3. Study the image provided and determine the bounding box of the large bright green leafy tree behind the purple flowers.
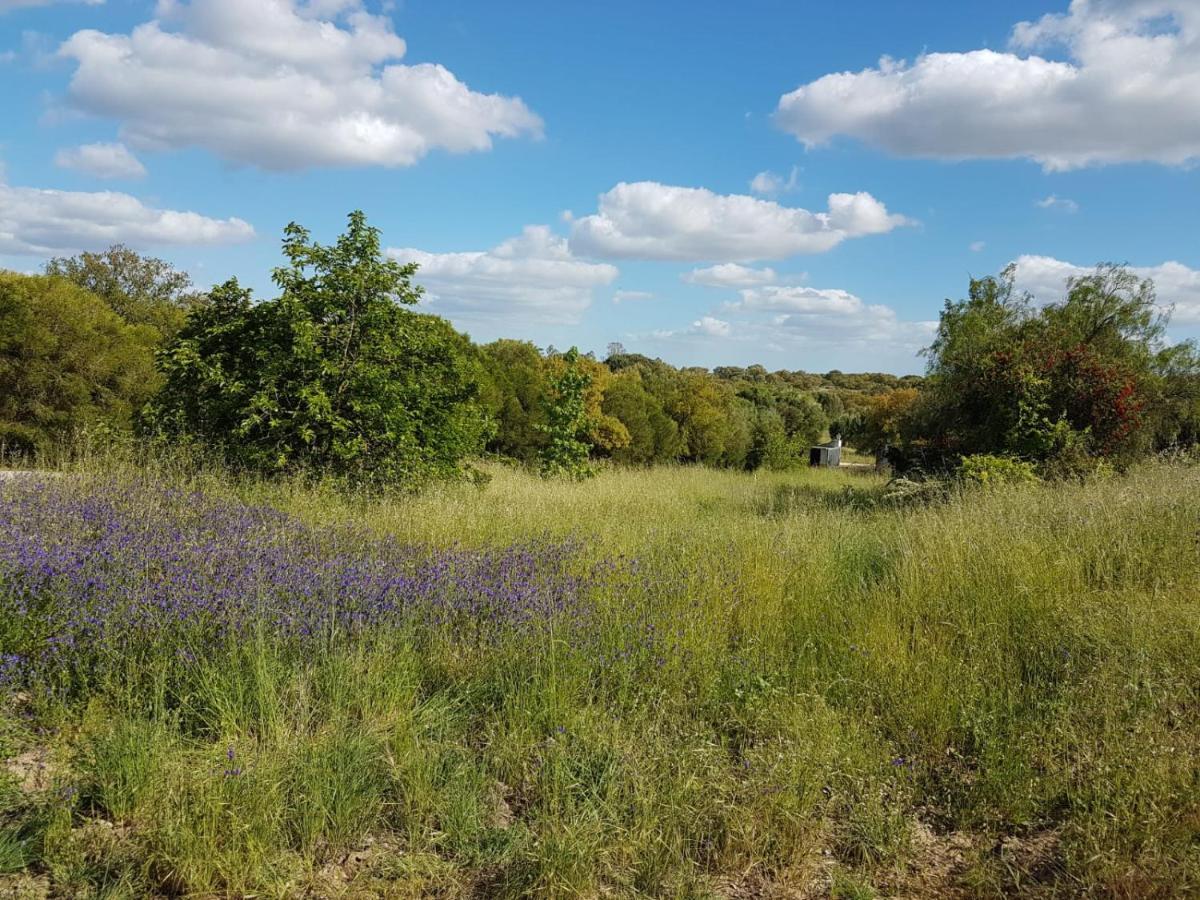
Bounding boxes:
[149,212,488,482]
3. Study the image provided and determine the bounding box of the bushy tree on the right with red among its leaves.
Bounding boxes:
[905,265,1194,470]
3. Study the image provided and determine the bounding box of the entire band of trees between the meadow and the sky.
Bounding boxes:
[0,214,1200,484]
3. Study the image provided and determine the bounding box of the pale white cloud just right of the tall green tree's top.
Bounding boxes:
[388,226,619,323]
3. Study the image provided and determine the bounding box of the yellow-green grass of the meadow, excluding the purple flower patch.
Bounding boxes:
[7,464,1200,898]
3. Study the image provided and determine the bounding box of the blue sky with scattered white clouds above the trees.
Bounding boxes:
[0,0,1200,373]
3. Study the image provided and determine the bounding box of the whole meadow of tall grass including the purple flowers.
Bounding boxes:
[0,463,1200,898]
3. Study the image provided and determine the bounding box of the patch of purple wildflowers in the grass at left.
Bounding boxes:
[0,479,599,682]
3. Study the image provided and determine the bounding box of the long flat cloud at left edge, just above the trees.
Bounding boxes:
[0,174,254,256]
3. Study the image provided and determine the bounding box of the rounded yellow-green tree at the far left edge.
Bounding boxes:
[0,272,158,452]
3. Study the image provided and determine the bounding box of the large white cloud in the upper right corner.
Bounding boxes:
[775,0,1200,170]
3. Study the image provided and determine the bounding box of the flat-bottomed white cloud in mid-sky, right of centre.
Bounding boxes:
[571,181,907,262]
